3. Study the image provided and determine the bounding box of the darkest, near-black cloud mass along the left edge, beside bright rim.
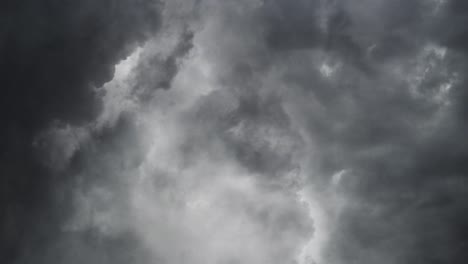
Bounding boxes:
[0,0,160,263]
